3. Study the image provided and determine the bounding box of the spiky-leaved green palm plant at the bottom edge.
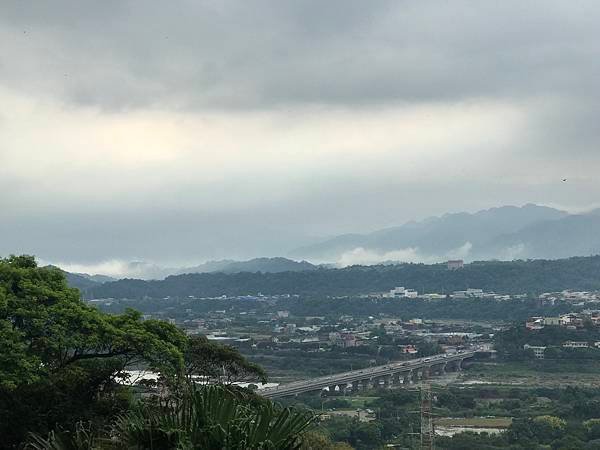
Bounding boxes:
[113,385,315,450]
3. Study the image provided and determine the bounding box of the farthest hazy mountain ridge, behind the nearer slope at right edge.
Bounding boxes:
[291,204,568,261]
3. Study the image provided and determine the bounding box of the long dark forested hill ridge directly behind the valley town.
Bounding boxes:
[83,256,600,298]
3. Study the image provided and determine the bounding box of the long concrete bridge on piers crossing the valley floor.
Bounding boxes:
[257,350,475,398]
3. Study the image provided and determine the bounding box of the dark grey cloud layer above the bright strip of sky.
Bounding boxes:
[0,1,600,109]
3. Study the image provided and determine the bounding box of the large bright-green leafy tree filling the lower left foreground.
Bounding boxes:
[0,256,187,448]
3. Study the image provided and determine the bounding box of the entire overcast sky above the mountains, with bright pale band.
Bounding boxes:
[0,0,600,270]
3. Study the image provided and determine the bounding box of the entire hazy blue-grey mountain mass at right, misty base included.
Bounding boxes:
[290,204,600,264]
